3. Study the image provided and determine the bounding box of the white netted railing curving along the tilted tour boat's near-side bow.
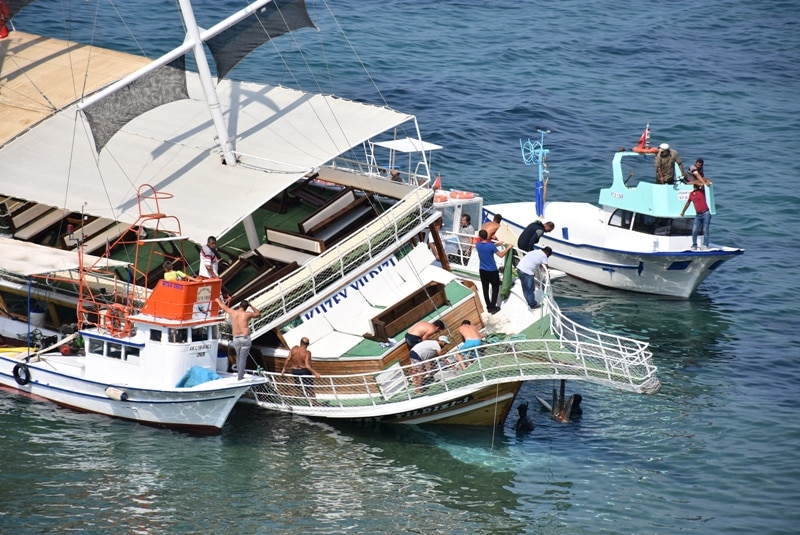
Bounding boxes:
[252,339,660,417]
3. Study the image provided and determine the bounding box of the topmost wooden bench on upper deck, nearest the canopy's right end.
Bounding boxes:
[297,188,376,245]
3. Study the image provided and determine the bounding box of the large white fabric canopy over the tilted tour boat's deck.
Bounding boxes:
[0,33,413,243]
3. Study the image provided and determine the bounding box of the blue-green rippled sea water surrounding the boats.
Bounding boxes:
[0,0,800,534]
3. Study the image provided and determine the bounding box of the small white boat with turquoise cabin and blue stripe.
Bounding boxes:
[484,127,744,298]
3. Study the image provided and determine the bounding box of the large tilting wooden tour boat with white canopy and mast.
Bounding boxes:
[0,0,659,425]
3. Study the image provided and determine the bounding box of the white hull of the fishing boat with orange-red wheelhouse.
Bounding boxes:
[0,356,260,433]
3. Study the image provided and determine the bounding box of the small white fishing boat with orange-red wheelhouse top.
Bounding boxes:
[0,186,265,433]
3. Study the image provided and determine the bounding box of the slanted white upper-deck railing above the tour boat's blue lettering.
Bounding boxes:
[245,188,434,336]
